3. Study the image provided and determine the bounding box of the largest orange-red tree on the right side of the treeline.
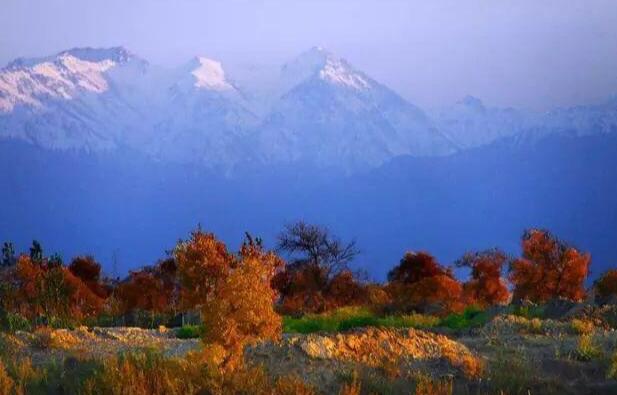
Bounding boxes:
[509,229,591,302]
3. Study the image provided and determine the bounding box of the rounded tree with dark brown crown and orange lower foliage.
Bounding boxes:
[386,252,463,314]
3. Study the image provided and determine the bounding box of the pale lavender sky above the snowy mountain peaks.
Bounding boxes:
[0,0,617,111]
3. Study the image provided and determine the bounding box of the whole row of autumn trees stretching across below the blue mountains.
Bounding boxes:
[0,222,617,334]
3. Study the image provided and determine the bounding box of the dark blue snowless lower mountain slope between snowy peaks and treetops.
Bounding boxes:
[0,134,617,278]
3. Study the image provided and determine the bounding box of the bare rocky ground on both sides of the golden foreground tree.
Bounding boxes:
[3,315,617,394]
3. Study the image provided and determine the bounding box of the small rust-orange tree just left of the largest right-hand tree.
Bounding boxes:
[456,249,510,307]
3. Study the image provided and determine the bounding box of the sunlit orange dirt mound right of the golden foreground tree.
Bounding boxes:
[246,328,482,393]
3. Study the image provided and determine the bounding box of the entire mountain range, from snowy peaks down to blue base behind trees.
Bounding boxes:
[0,47,617,277]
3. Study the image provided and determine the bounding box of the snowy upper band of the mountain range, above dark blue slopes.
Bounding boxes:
[0,47,617,172]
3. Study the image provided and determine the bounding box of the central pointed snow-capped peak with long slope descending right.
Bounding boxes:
[254,47,455,170]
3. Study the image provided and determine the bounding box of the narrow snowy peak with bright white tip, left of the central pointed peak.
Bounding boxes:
[147,57,257,168]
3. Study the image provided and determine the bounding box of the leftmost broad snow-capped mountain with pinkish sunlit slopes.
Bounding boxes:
[0,48,148,151]
